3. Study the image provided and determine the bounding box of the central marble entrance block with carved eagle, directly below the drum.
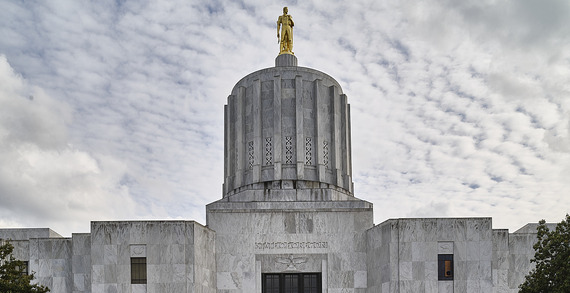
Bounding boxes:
[207,197,372,293]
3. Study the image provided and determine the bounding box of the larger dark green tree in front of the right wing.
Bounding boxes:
[519,215,570,293]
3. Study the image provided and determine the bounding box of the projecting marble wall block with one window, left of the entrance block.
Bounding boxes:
[91,221,215,293]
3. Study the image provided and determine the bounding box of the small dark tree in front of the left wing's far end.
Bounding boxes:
[0,242,50,293]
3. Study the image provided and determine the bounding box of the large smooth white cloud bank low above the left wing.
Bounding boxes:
[0,55,135,235]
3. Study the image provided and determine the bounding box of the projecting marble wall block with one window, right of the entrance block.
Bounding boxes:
[368,218,493,293]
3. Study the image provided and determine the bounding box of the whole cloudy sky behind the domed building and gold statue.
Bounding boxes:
[0,0,570,236]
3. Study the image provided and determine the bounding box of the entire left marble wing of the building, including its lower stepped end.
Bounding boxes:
[0,221,216,293]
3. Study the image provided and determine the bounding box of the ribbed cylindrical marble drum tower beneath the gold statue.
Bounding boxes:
[223,55,353,197]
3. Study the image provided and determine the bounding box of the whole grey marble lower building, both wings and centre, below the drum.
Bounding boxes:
[0,214,536,293]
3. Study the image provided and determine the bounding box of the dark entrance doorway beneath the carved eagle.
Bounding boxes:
[261,273,321,293]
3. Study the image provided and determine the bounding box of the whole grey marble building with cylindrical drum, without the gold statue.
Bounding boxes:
[0,54,536,293]
